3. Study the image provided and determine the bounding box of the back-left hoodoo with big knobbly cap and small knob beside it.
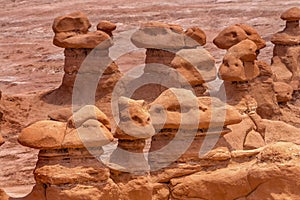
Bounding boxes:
[46,12,121,104]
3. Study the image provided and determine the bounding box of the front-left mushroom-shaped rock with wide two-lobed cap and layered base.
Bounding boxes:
[18,105,118,200]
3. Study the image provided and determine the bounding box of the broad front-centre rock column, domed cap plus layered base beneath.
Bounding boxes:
[149,88,242,183]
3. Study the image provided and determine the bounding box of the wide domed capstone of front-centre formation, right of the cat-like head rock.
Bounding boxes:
[150,88,242,129]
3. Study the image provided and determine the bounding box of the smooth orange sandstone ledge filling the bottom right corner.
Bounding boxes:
[170,143,300,200]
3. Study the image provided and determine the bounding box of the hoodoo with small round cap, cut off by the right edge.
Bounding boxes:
[271,7,300,90]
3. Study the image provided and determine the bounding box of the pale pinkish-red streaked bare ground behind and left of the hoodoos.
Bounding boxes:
[0,0,300,196]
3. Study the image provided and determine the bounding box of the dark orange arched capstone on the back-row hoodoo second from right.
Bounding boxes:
[213,24,266,50]
